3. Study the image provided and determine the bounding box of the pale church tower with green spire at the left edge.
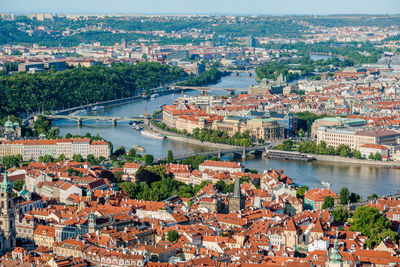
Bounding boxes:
[0,172,16,253]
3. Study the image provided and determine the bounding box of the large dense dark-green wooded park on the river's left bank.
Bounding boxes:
[0,62,186,116]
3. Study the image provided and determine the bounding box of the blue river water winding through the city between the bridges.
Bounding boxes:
[54,73,400,197]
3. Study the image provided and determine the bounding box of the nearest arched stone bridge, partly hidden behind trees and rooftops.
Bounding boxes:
[156,146,268,161]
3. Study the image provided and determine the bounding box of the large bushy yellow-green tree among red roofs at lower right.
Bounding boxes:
[351,206,399,249]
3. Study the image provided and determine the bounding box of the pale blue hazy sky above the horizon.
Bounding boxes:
[0,0,400,15]
